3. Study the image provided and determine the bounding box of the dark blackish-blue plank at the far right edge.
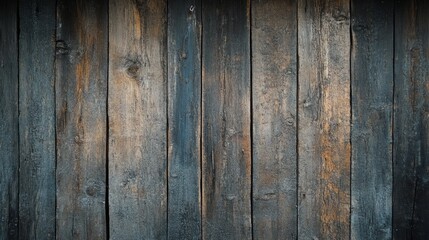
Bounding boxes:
[393,0,429,239]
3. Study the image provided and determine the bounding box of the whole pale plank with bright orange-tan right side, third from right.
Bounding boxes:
[298,0,351,239]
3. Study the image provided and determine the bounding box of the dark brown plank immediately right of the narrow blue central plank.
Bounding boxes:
[202,0,252,239]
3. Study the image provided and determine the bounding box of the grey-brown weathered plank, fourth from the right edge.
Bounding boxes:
[252,0,297,239]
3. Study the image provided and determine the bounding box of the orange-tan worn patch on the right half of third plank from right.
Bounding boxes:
[320,77,351,238]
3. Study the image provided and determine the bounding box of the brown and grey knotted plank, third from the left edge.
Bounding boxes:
[56,0,108,239]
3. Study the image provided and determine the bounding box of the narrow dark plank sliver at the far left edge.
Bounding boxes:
[0,0,19,239]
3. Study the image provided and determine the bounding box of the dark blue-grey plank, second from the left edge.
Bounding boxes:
[19,0,56,239]
